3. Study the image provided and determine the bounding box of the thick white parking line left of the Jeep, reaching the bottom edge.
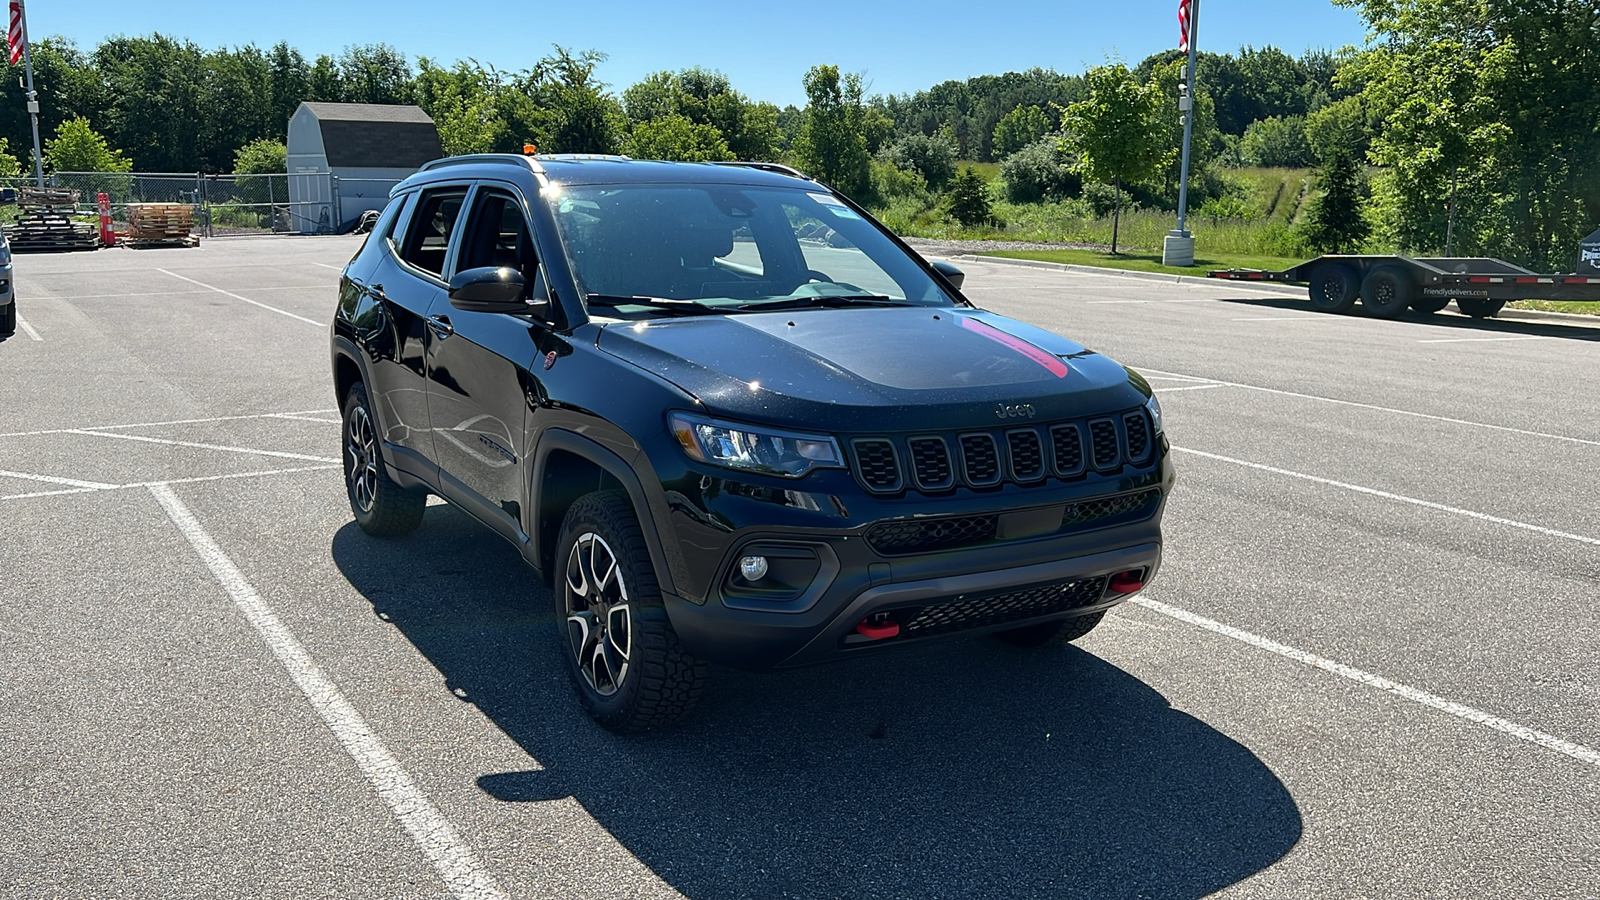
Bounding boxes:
[150,484,506,900]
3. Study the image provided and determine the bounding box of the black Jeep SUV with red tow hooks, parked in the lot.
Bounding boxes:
[333,155,1173,730]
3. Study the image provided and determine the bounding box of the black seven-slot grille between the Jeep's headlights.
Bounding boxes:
[851,410,1155,493]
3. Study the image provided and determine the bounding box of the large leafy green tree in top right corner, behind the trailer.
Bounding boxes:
[1339,0,1600,269]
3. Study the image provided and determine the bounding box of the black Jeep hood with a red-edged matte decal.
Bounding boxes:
[598,307,1150,432]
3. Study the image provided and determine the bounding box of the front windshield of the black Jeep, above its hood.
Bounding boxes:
[546,184,952,312]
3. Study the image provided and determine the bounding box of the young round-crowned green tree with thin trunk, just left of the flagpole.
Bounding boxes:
[1062,62,1174,253]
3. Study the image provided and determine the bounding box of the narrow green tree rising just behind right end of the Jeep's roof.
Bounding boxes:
[795,66,872,197]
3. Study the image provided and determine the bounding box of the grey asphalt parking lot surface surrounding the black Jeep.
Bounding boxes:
[0,239,1600,898]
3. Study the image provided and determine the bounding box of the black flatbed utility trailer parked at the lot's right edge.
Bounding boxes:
[1206,255,1600,319]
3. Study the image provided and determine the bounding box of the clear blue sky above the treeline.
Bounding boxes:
[37,0,1363,106]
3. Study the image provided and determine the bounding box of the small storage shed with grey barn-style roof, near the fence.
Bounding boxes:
[288,102,445,234]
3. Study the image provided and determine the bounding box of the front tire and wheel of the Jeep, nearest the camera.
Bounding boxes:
[550,490,706,733]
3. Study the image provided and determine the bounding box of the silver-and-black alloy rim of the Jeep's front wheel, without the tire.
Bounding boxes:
[565,532,634,697]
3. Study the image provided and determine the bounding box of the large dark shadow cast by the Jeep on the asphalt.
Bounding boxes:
[333,506,1302,898]
